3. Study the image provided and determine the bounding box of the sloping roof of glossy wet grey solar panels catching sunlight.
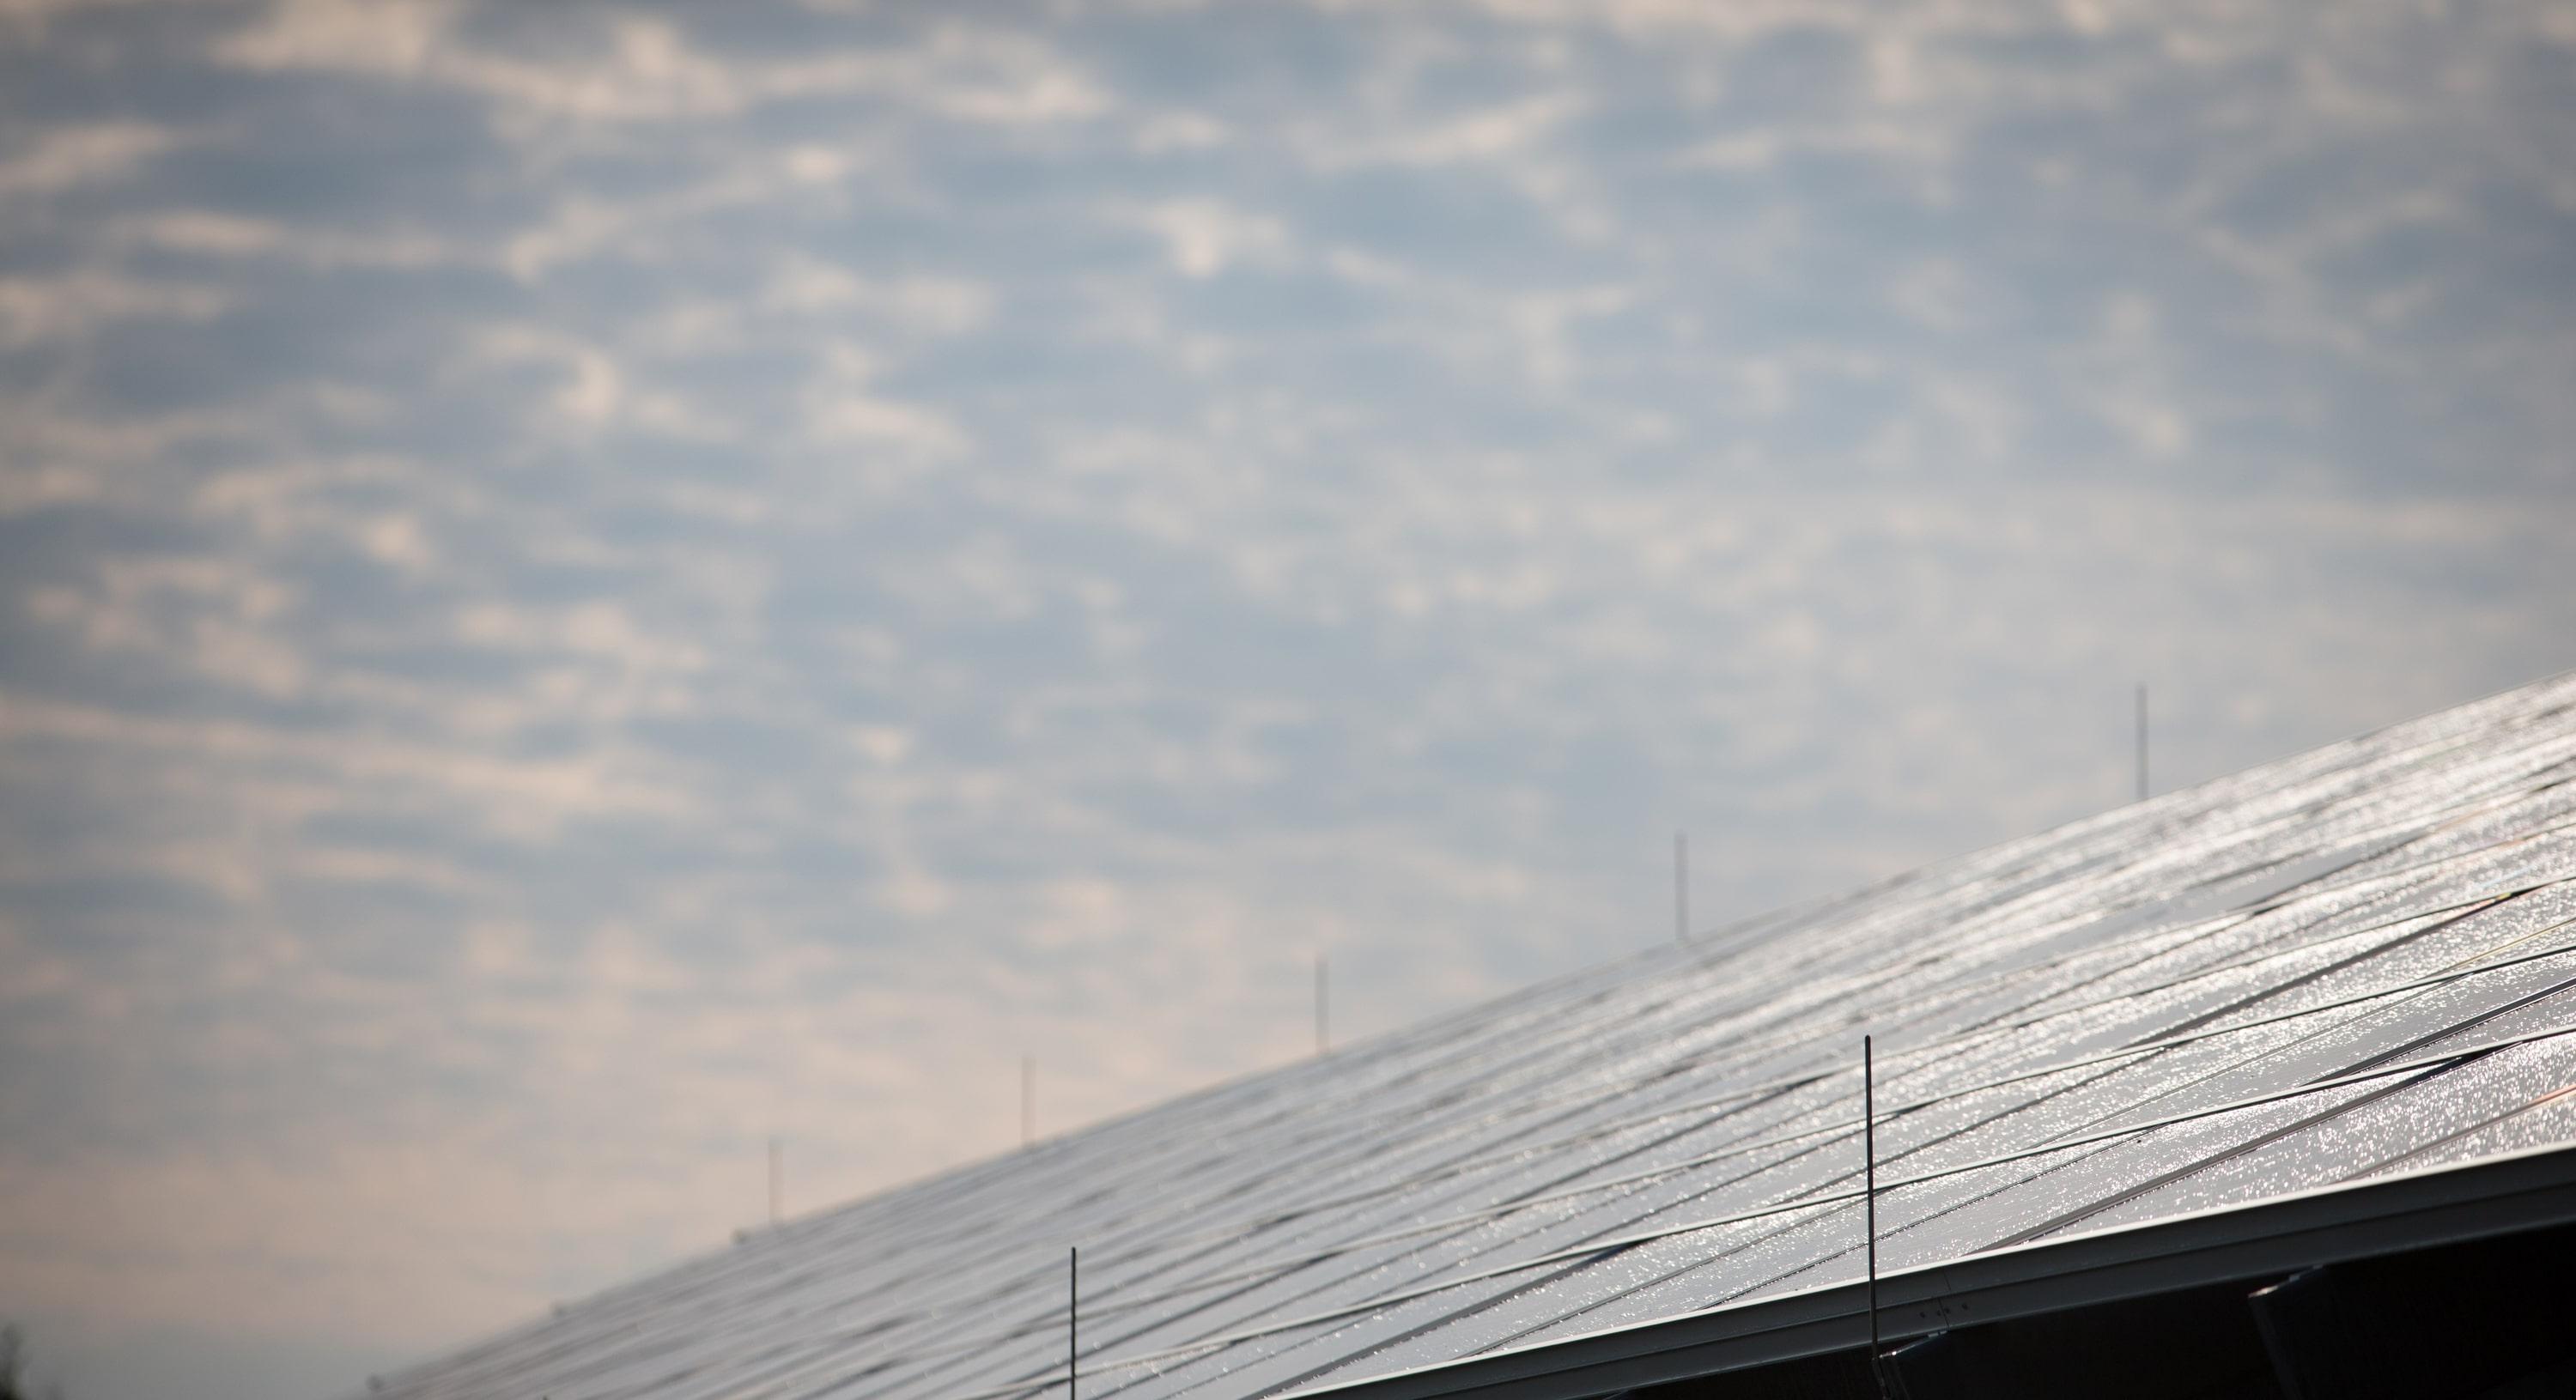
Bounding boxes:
[368,677,2576,1400]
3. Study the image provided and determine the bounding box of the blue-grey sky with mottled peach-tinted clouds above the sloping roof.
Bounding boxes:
[0,0,2576,1400]
